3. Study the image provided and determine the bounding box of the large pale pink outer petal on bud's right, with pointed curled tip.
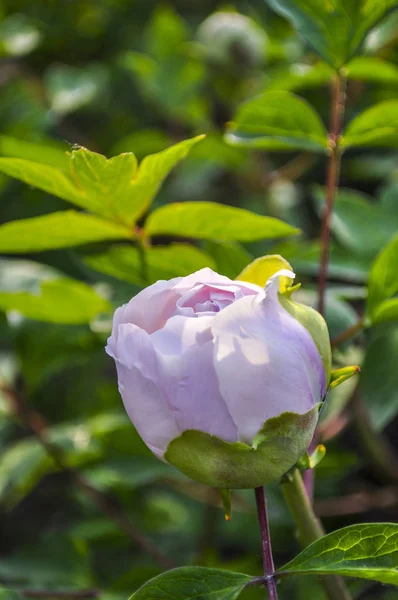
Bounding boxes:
[212,271,325,443]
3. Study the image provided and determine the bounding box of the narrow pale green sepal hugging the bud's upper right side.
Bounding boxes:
[279,294,332,385]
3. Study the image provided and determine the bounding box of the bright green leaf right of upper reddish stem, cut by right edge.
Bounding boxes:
[340,100,398,148]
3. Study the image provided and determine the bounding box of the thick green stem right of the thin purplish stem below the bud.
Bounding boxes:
[282,469,351,600]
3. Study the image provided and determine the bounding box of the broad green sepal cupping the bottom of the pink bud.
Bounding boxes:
[164,404,320,489]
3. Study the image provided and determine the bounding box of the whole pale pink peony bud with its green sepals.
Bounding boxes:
[106,269,330,488]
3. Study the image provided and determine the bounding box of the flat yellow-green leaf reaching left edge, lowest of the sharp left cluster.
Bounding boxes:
[0,210,133,254]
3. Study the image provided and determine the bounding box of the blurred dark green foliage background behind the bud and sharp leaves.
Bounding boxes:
[0,0,398,600]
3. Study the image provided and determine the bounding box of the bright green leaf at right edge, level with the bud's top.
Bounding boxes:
[366,235,398,321]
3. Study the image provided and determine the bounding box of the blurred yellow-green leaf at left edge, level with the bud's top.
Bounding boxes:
[0,279,111,323]
